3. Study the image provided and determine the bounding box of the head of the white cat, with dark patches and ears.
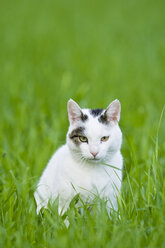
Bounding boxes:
[67,99,122,163]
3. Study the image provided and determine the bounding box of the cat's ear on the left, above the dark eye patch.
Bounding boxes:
[68,99,82,124]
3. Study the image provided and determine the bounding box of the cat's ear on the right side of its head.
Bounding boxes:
[103,99,121,123]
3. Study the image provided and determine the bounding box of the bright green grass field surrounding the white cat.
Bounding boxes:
[0,0,165,248]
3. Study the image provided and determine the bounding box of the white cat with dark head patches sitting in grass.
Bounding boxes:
[34,99,123,213]
